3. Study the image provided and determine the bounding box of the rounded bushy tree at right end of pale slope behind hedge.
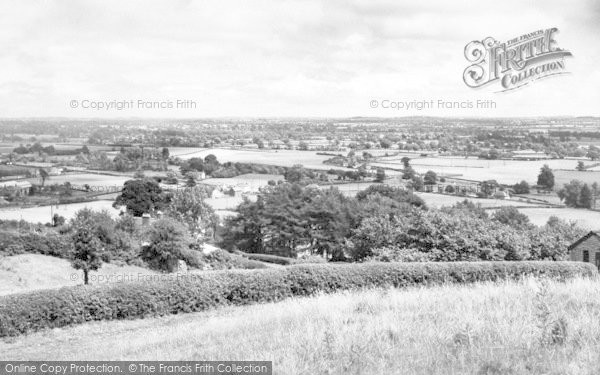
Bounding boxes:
[142,218,191,272]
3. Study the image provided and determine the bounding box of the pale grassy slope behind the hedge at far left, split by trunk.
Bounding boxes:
[0,254,156,295]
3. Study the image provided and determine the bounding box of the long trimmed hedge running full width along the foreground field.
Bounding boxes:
[0,262,597,337]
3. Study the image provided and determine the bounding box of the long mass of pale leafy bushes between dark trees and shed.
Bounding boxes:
[348,205,583,262]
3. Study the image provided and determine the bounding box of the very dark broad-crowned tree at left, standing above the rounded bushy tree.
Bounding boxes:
[113,179,167,216]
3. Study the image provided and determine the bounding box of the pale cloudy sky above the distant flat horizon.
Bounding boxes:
[0,0,600,118]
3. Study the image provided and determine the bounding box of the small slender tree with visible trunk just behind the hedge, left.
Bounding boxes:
[71,226,102,284]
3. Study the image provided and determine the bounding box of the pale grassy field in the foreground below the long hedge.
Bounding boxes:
[0,279,600,374]
